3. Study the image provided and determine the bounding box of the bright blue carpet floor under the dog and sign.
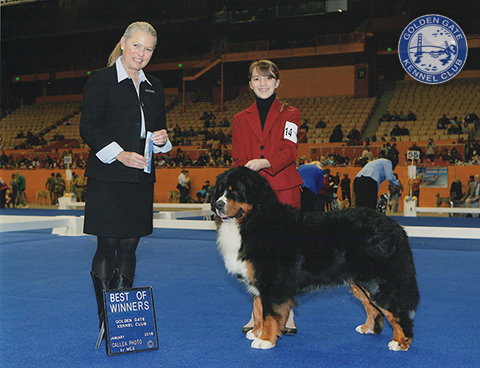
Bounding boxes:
[0,224,480,368]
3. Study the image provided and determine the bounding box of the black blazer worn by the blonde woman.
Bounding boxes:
[80,65,166,183]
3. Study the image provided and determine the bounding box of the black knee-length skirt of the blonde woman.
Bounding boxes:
[84,172,154,238]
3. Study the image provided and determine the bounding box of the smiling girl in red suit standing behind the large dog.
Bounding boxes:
[232,60,303,334]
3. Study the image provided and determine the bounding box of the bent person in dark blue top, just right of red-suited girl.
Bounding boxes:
[298,161,324,212]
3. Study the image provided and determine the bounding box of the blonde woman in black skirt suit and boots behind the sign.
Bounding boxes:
[80,22,172,344]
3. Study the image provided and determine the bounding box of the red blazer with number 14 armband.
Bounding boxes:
[232,99,303,190]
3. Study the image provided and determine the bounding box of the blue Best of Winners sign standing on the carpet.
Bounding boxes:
[104,287,158,355]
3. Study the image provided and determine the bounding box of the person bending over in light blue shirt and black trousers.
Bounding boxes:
[353,156,400,209]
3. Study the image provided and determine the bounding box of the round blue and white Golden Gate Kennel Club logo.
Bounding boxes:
[398,15,468,84]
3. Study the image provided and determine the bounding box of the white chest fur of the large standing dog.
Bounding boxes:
[217,222,247,279]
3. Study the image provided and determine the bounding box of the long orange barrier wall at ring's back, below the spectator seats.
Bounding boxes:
[0,165,480,209]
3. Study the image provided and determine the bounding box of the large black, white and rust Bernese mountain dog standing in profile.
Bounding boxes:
[211,167,419,351]
